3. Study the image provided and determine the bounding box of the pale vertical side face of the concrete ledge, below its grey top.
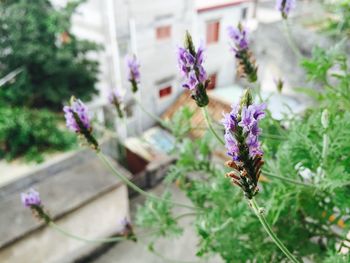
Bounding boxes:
[0,186,129,263]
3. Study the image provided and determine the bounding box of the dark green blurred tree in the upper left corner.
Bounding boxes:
[0,0,98,110]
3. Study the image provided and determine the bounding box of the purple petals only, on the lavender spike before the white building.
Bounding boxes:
[178,46,207,90]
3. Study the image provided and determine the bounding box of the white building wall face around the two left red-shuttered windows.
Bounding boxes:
[116,0,194,130]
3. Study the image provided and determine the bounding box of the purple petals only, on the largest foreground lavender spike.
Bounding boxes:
[222,104,266,161]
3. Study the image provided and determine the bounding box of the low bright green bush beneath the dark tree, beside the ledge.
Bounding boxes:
[0,108,75,162]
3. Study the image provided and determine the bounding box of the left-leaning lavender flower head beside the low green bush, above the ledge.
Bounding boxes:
[63,97,99,150]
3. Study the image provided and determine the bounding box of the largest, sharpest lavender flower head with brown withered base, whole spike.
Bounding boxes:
[222,90,266,199]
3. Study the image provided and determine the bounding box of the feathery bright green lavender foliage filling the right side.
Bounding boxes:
[135,39,350,262]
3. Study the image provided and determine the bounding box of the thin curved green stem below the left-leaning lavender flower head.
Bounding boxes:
[97,152,197,209]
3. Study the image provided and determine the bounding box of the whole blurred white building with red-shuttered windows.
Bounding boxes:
[53,0,253,135]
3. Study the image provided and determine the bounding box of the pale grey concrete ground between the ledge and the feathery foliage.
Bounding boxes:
[91,184,223,263]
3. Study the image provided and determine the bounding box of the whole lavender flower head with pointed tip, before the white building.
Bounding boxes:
[177,32,209,107]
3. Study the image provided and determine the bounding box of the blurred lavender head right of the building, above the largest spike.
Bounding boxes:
[227,24,258,82]
